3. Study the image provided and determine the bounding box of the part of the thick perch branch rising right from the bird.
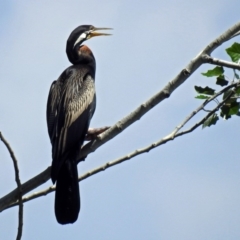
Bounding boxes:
[79,22,240,159]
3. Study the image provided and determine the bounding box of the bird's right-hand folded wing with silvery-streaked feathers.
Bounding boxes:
[52,75,96,181]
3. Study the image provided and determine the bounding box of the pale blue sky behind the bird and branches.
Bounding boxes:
[0,0,240,240]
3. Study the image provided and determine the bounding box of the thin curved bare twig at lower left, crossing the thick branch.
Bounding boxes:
[0,132,23,240]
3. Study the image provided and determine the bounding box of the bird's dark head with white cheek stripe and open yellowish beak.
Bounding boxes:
[66,25,111,64]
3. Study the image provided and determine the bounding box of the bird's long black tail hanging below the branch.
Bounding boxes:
[55,160,80,224]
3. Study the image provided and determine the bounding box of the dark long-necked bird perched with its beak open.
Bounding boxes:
[47,25,111,224]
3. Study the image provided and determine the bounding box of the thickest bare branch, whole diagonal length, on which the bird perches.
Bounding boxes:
[0,22,240,214]
